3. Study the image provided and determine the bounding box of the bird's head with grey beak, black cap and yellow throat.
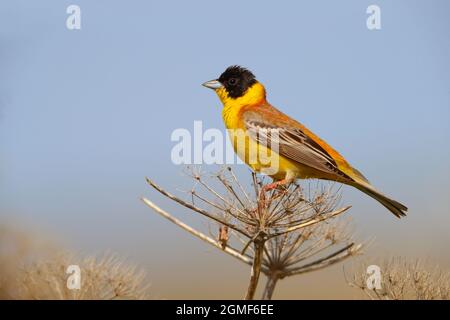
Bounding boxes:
[203,66,266,105]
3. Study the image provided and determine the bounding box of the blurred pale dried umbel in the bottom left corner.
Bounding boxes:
[19,254,147,300]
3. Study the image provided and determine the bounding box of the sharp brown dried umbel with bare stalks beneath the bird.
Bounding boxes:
[143,167,361,299]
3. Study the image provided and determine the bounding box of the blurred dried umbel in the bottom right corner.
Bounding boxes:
[347,258,450,300]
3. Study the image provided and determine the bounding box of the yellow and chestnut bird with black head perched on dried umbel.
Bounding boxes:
[203,65,408,218]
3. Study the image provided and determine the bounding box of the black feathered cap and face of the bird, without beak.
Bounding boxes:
[217,66,257,99]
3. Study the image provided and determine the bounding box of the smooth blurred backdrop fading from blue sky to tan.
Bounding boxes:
[0,0,450,299]
